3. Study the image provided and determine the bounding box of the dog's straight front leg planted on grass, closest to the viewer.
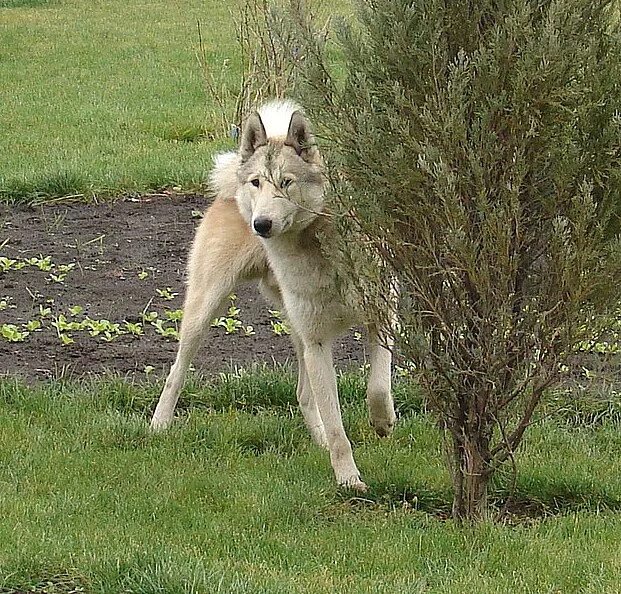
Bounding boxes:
[304,342,367,491]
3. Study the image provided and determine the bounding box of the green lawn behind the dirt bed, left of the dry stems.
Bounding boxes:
[0,0,237,200]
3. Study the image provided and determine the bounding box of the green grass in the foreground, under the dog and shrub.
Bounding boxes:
[0,370,621,594]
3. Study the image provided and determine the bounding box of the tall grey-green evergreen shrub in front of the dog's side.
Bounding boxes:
[292,0,621,516]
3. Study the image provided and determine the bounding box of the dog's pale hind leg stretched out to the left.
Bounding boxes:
[151,273,237,430]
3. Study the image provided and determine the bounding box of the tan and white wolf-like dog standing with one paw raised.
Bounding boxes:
[151,101,395,490]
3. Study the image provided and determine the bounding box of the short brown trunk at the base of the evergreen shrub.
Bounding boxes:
[451,427,492,523]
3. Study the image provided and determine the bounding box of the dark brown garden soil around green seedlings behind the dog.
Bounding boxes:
[0,193,364,380]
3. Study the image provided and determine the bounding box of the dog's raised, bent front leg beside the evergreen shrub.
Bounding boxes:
[367,326,397,437]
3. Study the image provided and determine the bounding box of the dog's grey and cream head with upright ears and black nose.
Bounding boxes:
[236,103,324,238]
